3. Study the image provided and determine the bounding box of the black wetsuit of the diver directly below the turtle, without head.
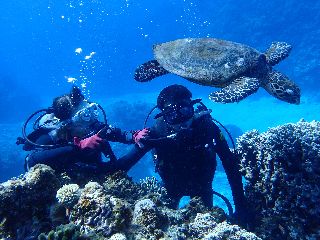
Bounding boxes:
[116,114,245,211]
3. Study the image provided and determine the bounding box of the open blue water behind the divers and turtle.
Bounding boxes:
[0,0,320,210]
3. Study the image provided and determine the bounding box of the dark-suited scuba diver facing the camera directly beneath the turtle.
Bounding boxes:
[114,85,248,226]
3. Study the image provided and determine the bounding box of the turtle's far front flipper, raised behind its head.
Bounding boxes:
[265,42,292,66]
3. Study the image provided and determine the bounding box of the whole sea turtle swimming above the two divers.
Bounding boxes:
[134,38,300,104]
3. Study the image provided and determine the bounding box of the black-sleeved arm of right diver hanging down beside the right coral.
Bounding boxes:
[214,125,246,213]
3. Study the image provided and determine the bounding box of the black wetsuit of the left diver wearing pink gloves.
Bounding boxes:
[24,123,134,174]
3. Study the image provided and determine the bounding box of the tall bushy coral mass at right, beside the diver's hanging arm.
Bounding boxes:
[237,120,320,239]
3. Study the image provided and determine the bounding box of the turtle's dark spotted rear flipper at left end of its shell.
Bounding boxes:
[134,60,169,82]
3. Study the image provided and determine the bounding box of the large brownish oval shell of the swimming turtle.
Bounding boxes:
[153,38,261,87]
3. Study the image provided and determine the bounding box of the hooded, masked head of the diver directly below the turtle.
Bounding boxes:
[156,84,194,125]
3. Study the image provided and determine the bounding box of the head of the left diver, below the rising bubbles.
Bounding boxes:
[52,95,73,121]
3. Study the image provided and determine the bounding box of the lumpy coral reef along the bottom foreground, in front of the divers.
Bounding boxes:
[0,165,259,240]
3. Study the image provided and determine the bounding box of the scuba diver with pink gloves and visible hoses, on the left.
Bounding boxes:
[17,86,137,174]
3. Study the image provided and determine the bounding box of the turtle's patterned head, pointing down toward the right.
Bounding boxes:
[262,70,300,104]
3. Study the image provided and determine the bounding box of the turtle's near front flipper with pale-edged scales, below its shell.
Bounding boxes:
[209,77,260,103]
